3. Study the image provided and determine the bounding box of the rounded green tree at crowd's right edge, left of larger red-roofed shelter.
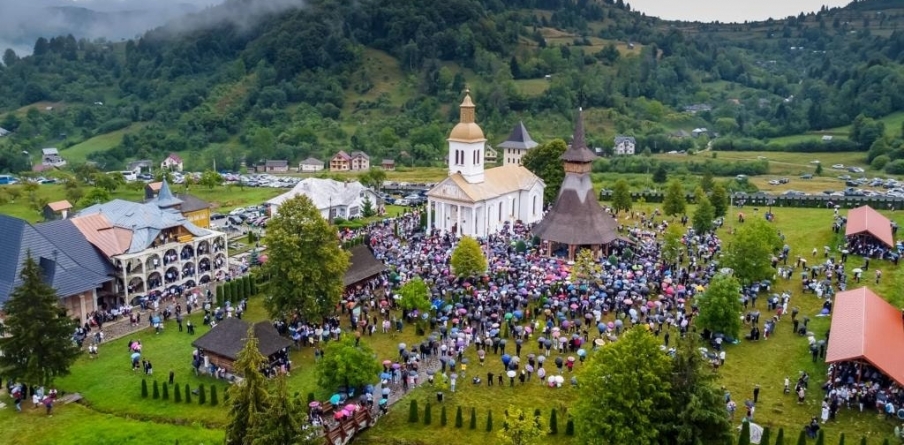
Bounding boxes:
[695,274,742,337]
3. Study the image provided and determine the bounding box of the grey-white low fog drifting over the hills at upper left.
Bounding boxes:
[0,0,304,56]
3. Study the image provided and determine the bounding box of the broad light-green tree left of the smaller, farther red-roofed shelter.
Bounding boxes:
[724,218,782,284]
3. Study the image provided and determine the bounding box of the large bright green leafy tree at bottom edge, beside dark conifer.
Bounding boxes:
[571,328,672,445]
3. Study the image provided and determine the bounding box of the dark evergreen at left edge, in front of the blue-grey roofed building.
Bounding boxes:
[0,253,80,387]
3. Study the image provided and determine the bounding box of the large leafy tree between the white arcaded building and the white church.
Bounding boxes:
[259,195,350,320]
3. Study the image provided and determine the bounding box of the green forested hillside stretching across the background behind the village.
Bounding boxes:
[0,0,904,171]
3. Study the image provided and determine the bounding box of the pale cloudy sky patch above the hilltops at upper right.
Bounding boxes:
[625,0,850,22]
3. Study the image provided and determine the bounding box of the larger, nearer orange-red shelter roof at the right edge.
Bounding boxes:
[826,287,904,385]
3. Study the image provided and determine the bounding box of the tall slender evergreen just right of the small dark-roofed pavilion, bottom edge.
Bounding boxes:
[226,328,272,445]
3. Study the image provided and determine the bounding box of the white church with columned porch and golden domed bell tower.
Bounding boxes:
[427,91,546,237]
